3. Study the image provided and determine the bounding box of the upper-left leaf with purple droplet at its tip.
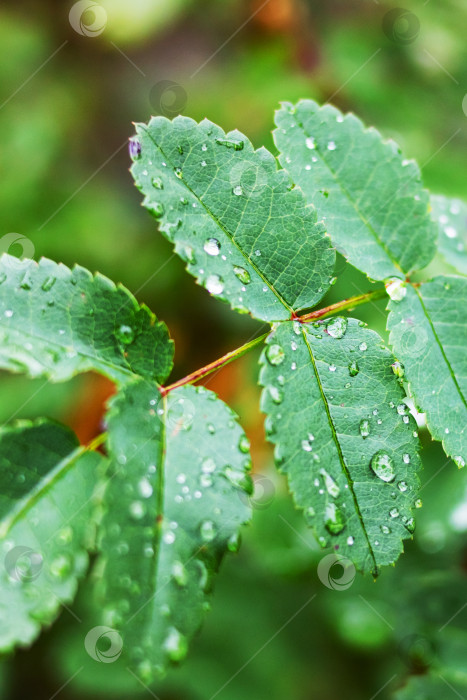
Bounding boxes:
[130,117,335,321]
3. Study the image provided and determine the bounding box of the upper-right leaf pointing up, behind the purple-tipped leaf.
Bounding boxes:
[274,100,436,280]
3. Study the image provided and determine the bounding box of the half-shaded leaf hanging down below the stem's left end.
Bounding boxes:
[94,380,252,682]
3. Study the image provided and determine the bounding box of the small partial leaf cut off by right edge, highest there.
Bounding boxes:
[431,195,467,275]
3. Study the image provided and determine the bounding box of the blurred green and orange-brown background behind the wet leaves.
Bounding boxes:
[0,0,467,700]
